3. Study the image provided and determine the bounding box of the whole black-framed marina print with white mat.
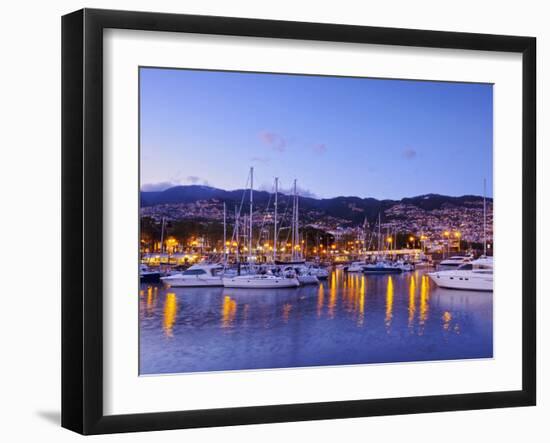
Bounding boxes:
[62,9,536,434]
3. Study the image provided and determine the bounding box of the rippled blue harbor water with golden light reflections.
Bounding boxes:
[139,270,493,375]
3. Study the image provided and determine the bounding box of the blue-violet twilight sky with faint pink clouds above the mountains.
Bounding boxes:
[140,68,493,199]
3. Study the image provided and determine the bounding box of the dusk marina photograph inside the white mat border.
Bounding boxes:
[136,68,494,375]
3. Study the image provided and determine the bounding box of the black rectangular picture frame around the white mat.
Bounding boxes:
[62,9,536,434]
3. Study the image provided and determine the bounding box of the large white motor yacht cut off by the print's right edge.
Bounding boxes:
[428,257,493,291]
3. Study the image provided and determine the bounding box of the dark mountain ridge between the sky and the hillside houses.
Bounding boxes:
[141,185,492,223]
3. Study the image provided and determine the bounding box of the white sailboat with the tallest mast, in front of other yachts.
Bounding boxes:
[222,168,300,289]
